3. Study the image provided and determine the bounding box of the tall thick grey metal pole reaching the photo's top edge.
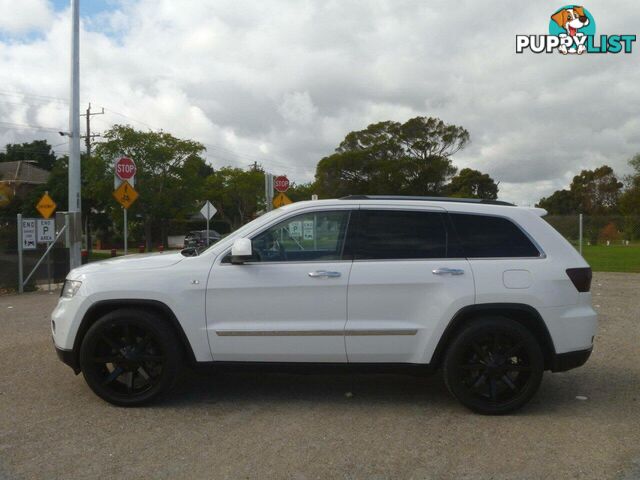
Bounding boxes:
[69,0,82,269]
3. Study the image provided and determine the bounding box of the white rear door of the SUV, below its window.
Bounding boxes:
[345,259,474,363]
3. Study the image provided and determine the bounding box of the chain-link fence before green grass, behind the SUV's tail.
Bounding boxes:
[544,215,640,273]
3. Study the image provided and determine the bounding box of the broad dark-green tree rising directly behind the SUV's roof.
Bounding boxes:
[315,117,469,197]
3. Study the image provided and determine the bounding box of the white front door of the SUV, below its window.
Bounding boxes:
[206,261,352,362]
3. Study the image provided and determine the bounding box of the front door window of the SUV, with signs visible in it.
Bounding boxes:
[251,210,350,262]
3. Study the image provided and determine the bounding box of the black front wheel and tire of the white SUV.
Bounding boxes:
[80,309,182,407]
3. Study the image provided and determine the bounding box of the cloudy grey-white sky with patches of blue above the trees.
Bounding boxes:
[0,0,640,205]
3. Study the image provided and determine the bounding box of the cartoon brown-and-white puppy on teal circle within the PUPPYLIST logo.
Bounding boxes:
[549,5,595,55]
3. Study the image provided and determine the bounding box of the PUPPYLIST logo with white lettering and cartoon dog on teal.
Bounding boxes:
[516,5,636,55]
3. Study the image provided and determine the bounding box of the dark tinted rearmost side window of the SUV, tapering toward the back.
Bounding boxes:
[450,213,540,258]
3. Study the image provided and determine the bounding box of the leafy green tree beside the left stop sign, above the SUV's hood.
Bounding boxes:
[95,125,208,249]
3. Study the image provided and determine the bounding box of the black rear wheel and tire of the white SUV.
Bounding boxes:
[443,317,544,415]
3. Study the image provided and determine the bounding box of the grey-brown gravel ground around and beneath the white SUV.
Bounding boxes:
[0,273,640,480]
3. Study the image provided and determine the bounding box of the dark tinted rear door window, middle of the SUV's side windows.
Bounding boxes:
[350,210,447,260]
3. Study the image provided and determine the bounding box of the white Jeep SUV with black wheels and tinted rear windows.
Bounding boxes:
[51,196,597,414]
